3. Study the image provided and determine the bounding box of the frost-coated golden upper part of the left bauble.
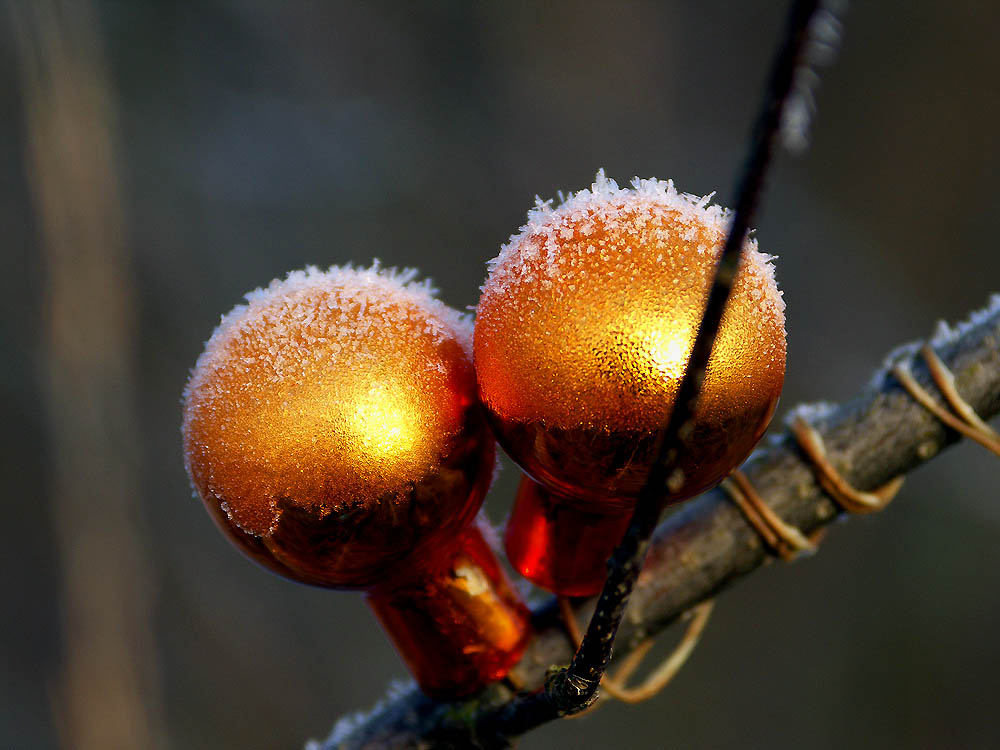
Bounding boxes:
[183,262,492,537]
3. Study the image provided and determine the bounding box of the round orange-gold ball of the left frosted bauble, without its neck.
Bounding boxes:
[183,265,495,588]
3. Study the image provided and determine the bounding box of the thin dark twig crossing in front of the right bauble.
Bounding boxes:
[478,0,820,747]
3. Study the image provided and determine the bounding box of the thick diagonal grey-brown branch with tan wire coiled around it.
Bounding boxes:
[308,296,1000,750]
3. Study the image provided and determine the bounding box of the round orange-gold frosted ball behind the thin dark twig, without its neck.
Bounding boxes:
[474,172,785,504]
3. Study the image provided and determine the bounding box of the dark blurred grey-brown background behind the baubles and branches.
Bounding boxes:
[0,0,1000,750]
